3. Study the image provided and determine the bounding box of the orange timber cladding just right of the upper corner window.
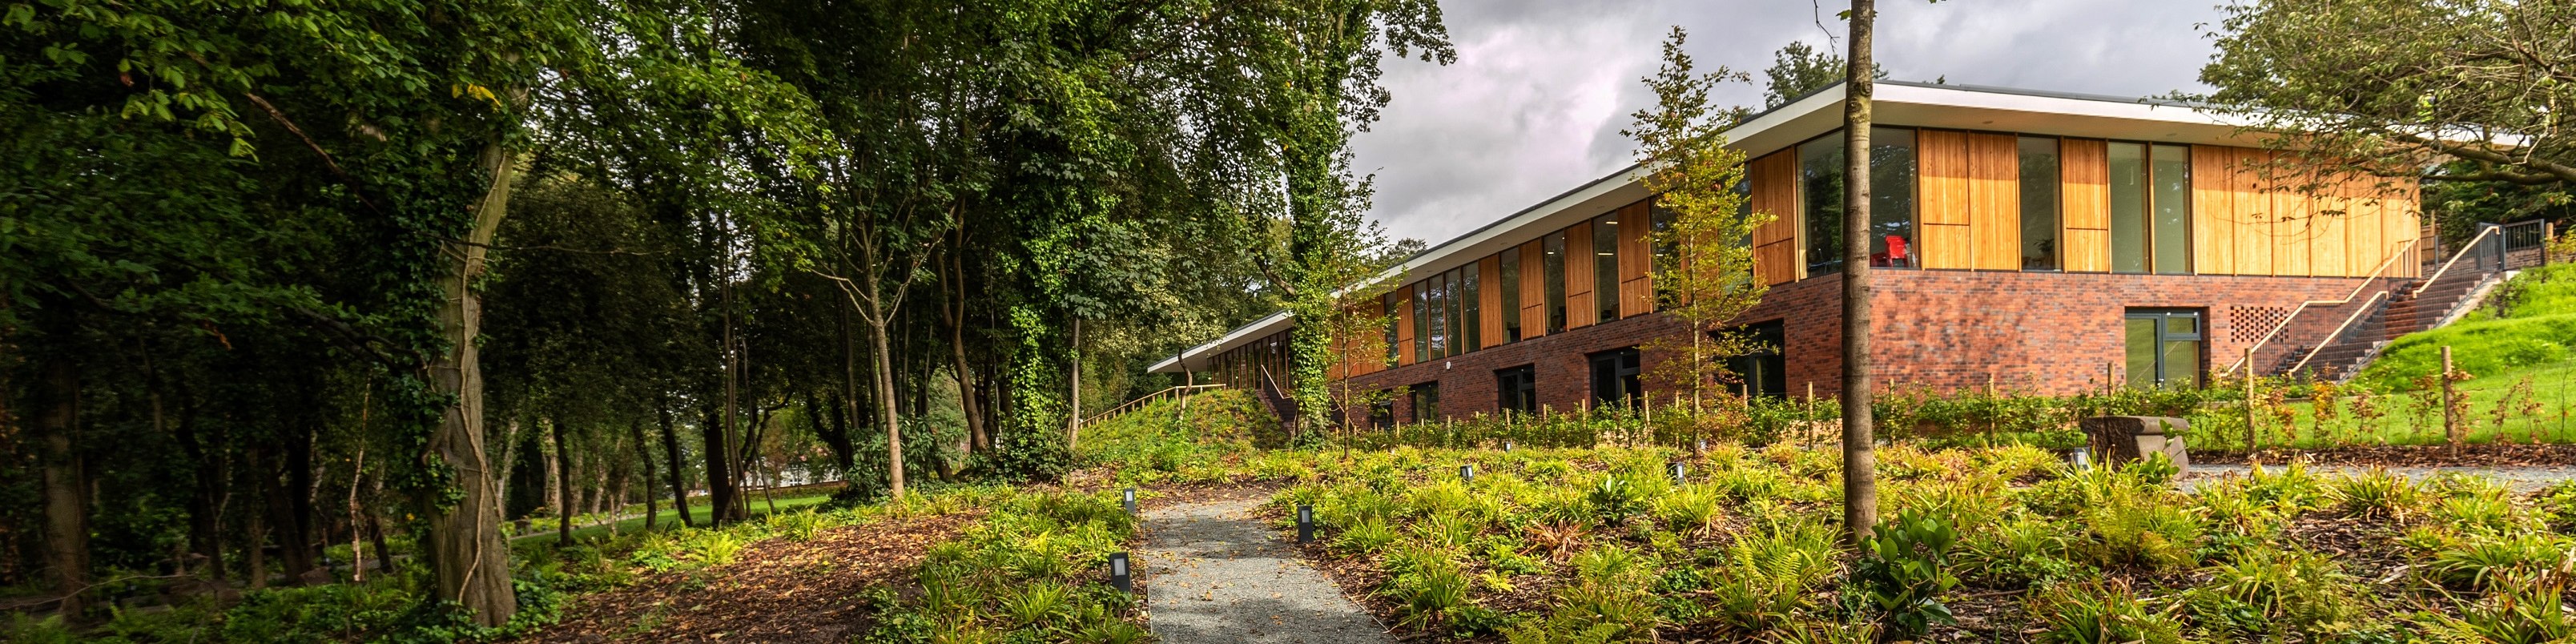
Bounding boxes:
[1914,129,2023,271]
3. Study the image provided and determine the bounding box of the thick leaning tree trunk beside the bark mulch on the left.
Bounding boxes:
[415,142,517,626]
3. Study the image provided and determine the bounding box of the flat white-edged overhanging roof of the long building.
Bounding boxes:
[1149,80,2262,373]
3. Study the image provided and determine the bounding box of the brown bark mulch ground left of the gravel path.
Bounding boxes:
[525,513,981,642]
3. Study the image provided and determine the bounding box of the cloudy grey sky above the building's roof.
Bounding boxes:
[1352,0,2220,245]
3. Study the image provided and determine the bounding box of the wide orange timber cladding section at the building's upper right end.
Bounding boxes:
[2192,147,2417,276]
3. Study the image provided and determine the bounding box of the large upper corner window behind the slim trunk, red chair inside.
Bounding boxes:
[1798,129,1917,276]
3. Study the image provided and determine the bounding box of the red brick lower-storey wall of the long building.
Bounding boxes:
[1360,271,2362,420]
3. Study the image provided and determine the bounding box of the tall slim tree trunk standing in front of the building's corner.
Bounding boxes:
[1841,0,1878,544]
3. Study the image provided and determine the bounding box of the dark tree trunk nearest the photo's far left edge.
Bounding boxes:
[36,350,91,621]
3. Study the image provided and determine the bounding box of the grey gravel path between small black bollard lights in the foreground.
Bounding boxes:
[1136,500,1394,644]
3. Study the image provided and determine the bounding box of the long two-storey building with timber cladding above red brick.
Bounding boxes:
[1154,83,2483,422]
